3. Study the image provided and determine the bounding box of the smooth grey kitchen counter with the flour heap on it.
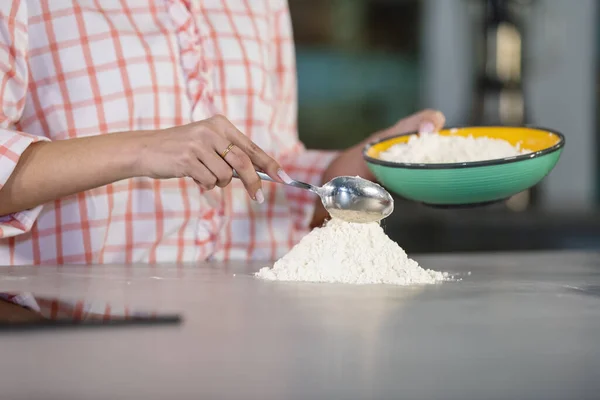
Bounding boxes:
[0,252,600,400]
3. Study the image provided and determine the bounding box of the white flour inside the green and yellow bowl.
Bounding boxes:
[379,133,530,164]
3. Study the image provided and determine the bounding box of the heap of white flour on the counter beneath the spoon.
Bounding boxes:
[256,218,448,285]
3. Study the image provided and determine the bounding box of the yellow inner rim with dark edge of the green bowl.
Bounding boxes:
[363,125,565,169]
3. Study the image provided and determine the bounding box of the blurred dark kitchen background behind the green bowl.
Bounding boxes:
[289,0,600,253]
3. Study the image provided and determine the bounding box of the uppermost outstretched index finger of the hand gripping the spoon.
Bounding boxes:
[211,116,287,181]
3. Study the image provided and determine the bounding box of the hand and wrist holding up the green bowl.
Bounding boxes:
[311,110,446,227]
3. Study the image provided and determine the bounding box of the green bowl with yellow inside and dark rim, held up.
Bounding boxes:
[363,127,565,207]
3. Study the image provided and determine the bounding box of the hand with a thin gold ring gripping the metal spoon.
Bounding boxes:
[136,115,287,203]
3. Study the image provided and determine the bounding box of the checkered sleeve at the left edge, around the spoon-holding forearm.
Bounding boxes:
[0,0,48,238]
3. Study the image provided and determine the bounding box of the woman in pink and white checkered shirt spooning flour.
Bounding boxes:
[0,0,444,265]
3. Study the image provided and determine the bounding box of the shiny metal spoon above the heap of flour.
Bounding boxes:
[233,170,394,223]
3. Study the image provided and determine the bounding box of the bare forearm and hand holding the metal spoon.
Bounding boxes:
[0,116,286,216]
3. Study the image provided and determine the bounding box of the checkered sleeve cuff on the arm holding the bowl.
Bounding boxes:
[279,148,339,230]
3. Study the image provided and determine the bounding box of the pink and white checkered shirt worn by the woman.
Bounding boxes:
[0,0,334,265]
